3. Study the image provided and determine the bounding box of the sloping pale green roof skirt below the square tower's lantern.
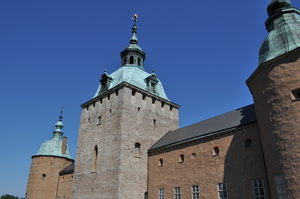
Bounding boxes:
[94,64,170,101]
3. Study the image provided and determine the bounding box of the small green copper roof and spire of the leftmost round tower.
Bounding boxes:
[35,116,72,159]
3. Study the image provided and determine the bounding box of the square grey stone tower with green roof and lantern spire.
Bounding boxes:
[72,17,179,199]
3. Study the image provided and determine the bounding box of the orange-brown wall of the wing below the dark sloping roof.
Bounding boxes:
[148,124,269,199]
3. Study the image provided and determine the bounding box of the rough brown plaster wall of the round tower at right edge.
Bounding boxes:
[247,48,300,198]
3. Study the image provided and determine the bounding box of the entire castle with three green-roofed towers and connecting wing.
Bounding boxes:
[26,0,300,199]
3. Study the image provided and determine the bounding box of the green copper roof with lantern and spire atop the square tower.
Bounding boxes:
[94,24,170,101]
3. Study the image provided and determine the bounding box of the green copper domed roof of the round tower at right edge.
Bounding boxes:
[259,0,300,65]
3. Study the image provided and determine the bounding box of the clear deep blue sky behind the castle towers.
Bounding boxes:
[0,0,300,197]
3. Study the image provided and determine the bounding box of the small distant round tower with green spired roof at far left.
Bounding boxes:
[26,112,74,199]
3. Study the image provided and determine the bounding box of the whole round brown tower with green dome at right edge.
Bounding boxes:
[247,0,300,199]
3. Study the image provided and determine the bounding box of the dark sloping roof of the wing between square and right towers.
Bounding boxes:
[149,104,256,151]
